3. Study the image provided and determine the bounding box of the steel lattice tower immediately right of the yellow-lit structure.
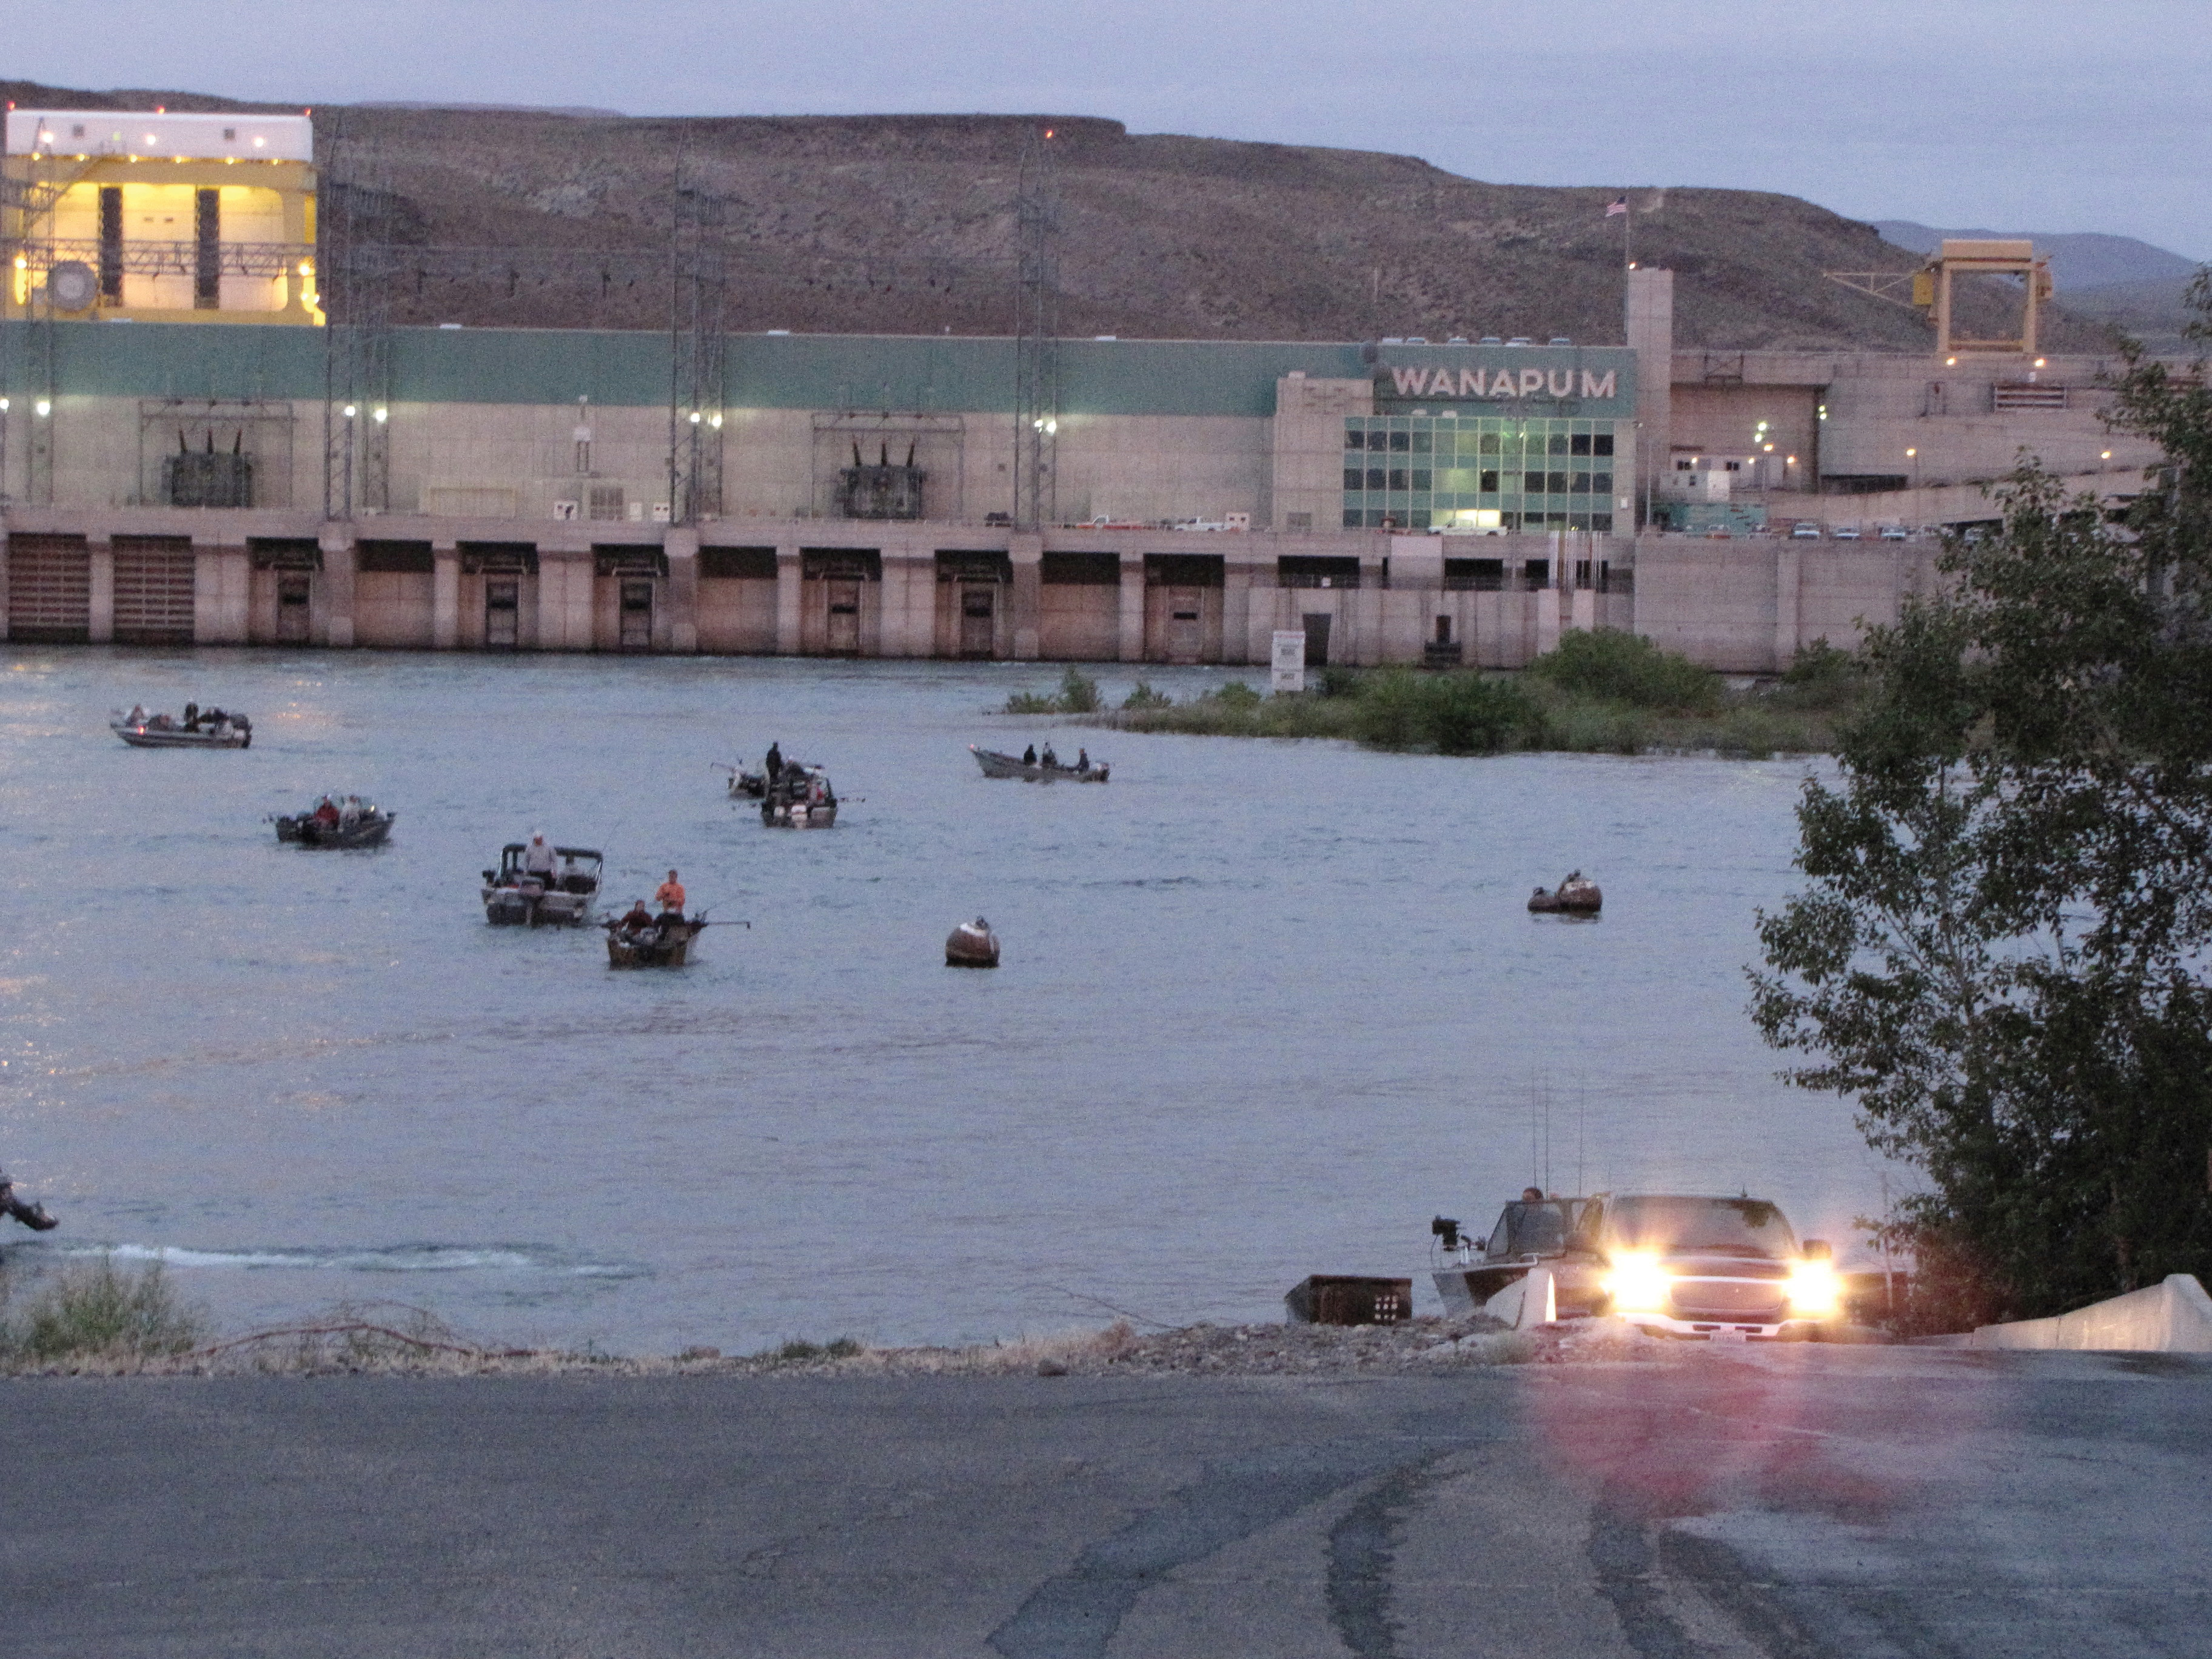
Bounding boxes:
[317,115,392,520]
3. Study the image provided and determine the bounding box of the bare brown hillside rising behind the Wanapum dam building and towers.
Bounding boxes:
[0,82,2110,349]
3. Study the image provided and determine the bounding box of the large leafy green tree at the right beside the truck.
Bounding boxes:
[1752,272,2212,1329]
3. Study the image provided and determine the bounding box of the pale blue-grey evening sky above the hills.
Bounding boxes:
[17,0,2212,259]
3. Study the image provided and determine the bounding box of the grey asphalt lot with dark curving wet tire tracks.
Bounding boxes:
[0,1347,2212,1659]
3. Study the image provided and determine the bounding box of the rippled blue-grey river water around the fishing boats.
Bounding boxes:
[0,646,1880,1352]
